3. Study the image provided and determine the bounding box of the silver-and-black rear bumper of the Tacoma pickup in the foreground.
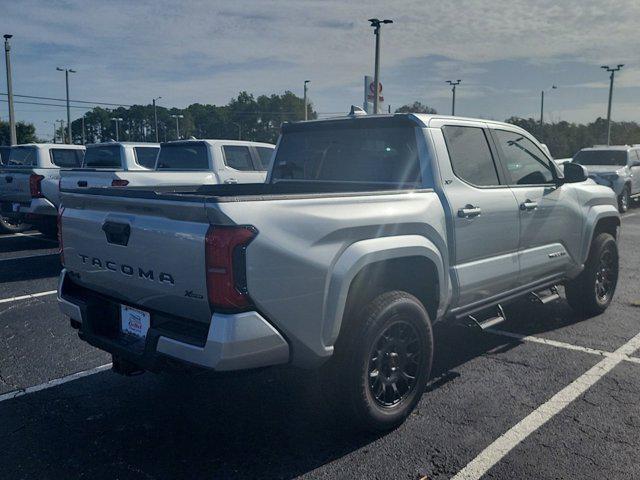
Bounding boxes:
[58,269,289,371]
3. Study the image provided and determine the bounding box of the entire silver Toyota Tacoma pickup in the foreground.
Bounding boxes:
[58,114,620,430]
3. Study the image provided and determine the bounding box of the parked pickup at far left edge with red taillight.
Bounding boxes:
[0,143,84,235]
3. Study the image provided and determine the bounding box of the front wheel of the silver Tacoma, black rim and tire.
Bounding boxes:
[565,233,618,316]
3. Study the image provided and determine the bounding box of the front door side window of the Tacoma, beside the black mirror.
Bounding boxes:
[493,130,554,185]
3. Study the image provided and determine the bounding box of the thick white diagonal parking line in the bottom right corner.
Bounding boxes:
[453,334,640,480]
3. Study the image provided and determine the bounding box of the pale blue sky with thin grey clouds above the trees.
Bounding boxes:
[0,0,640,138]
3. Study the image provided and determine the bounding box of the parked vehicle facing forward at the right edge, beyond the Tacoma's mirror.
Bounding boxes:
[573,145,640,213]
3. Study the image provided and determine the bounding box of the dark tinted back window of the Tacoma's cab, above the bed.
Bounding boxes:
[271,118,421,188]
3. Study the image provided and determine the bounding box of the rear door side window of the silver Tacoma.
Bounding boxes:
[442,125,500,187]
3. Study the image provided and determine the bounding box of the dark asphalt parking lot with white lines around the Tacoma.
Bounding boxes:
[0,215,640,479]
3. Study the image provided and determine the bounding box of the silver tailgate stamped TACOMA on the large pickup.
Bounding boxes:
[62,193,211,323]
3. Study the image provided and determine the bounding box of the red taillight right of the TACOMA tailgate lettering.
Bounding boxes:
[205,226,258,310]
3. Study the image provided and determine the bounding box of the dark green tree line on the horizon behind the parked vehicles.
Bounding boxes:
[0,98,640,158]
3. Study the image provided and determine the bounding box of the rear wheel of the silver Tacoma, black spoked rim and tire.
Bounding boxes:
[323,291,433,432]
